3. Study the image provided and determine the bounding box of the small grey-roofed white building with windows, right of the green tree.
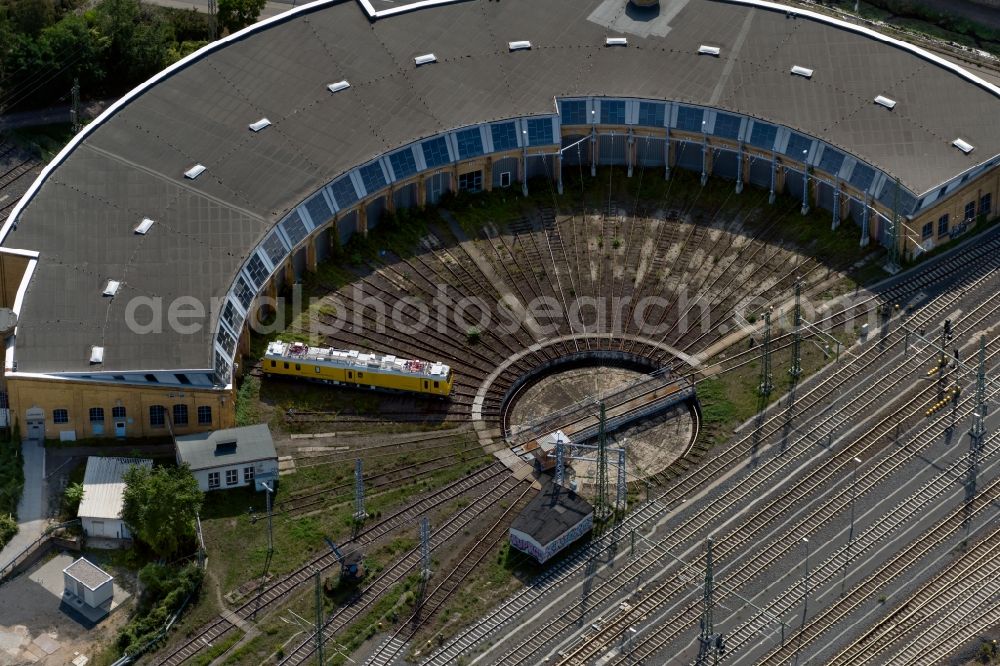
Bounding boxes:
[174,424,278,492]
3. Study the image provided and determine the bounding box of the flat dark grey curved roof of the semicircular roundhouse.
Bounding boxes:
[3,0,1000,373]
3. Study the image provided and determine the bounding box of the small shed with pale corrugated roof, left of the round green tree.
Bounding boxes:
[76,456,153,540]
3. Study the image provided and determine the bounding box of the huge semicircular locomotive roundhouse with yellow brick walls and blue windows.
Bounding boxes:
[0,0,1000,437]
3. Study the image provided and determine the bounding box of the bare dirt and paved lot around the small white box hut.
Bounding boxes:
[0,554,131,666]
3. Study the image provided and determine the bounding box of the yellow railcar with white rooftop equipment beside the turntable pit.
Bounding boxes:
[261,342,453,397]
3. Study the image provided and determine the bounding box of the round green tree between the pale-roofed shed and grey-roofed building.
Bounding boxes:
[122,465,204,557]
